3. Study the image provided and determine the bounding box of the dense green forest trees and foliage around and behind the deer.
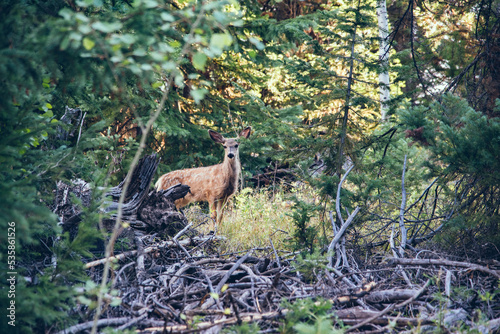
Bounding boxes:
[0,0,500,333]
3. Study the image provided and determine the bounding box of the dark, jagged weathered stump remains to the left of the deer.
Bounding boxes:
[53,154,189,237]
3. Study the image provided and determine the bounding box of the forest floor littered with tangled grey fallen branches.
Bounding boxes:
[56,220,500,334]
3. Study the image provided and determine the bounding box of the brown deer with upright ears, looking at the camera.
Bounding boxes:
[155,127,252,223]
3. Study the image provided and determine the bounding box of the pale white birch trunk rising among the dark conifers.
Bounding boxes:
[377,0,391,121]
